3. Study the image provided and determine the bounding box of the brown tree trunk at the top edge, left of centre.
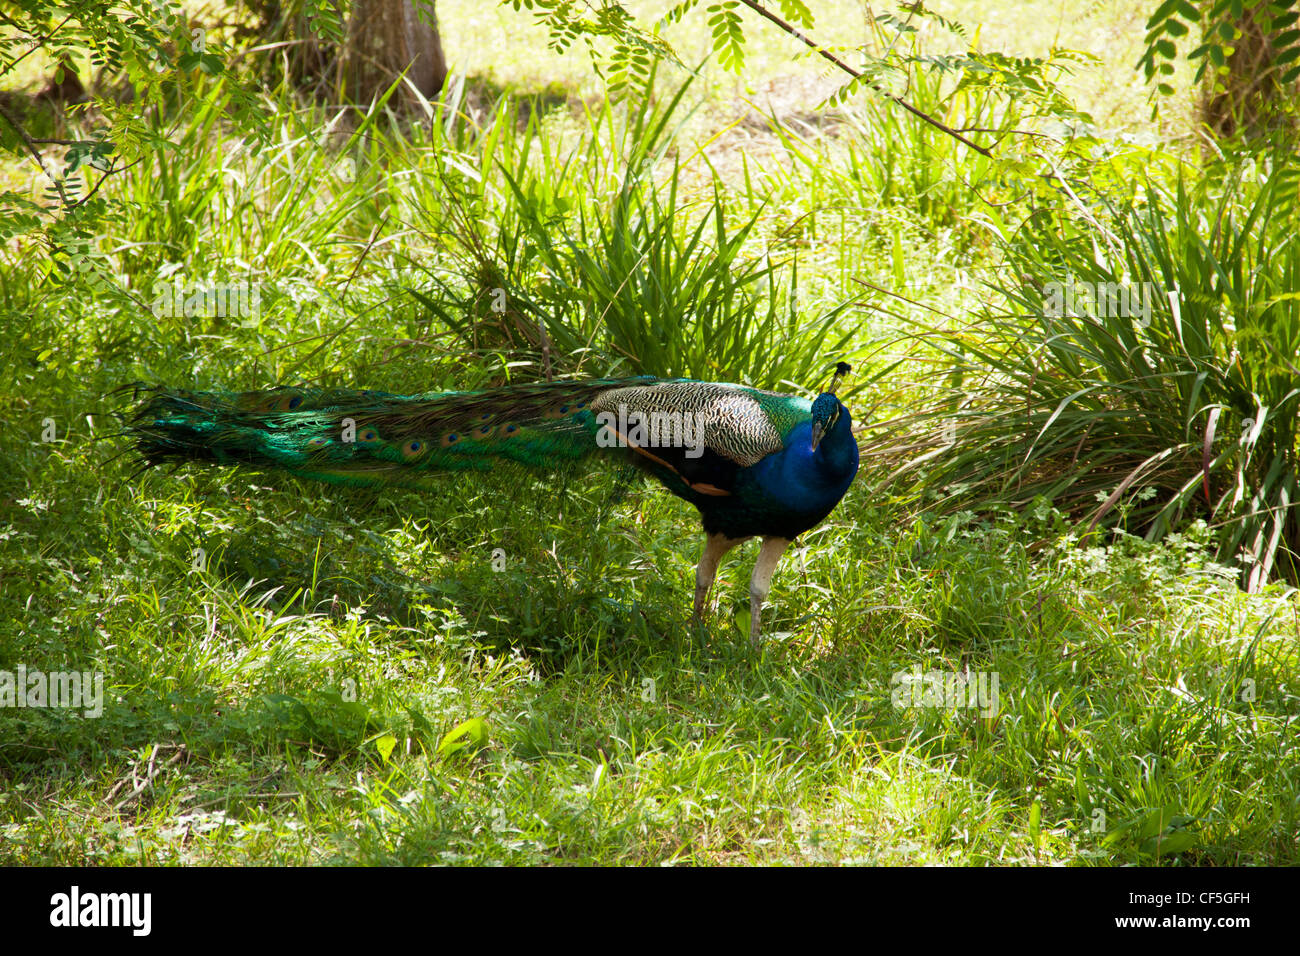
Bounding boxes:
[345,0,447,104]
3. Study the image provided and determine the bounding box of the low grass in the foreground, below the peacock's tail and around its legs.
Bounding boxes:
[4,460,1300,864]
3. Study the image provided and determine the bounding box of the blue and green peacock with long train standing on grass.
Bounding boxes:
[125,362,858,644]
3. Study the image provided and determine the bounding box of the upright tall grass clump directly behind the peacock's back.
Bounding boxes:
[400,70,852,386]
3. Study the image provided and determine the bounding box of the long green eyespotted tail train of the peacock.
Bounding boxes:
[126,376,657,485]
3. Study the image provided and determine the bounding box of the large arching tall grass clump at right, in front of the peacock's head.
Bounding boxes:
[880,161,1300,589]
